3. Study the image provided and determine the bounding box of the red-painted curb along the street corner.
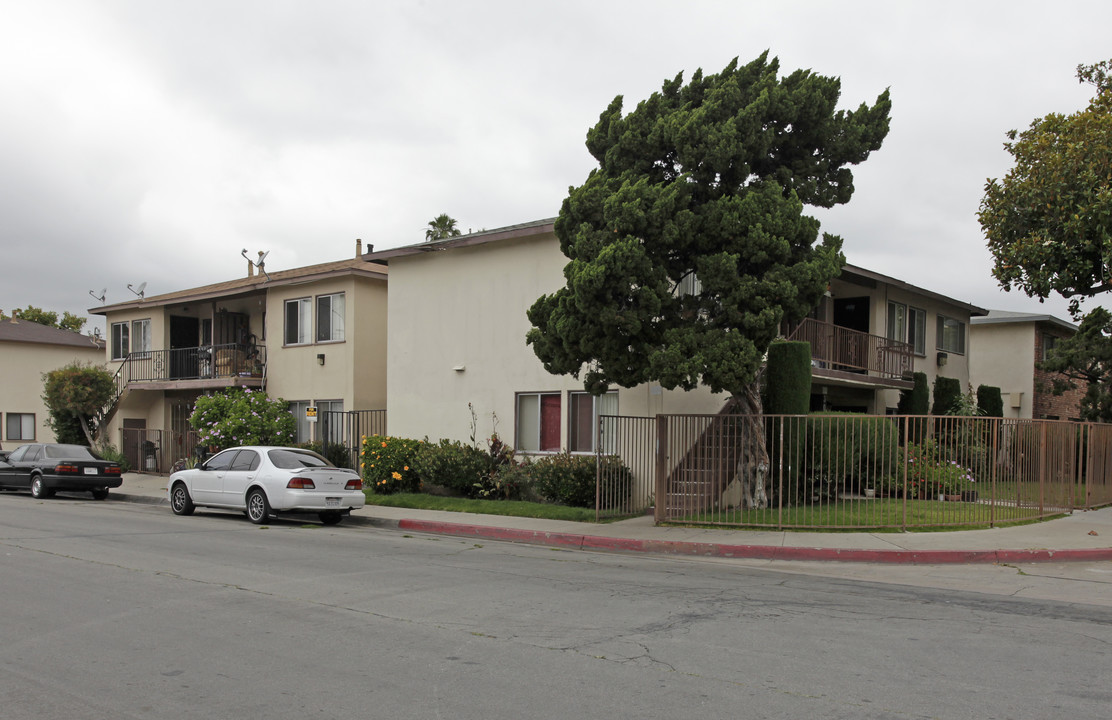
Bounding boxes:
[398,520,1112,565]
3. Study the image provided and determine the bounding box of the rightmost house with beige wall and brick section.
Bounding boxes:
[970,310,1085,420]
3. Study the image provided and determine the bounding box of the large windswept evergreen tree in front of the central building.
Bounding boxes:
[527,52,891,504]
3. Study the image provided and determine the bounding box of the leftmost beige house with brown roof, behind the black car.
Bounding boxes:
[0,319,105,450]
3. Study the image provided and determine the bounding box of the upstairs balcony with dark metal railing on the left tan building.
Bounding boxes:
[116,344,267,389]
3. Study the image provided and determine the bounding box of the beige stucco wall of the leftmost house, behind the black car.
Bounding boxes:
[0,341,105,450]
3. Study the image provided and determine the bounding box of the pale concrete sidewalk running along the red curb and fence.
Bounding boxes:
[109,473,1112,564]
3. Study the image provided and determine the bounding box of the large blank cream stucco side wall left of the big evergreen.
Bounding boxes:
[387,233,725,447]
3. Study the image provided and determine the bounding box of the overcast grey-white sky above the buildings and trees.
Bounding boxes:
[0,0,1112,331]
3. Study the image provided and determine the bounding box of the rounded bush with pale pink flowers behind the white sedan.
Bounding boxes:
[189,388,297,450]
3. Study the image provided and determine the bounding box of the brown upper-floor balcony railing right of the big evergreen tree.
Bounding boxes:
[787,317,914,379]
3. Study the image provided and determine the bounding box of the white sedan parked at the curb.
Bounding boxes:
[167,446,367,525]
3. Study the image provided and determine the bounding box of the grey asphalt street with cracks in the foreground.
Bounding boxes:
[0,494,1112,720]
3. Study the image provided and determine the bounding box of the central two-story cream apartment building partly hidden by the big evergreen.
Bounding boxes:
[365,219,986,452]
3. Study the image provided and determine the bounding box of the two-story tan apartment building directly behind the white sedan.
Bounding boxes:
[89,241,387,471]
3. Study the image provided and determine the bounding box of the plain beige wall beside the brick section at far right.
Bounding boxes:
[970,323,1035,417]
